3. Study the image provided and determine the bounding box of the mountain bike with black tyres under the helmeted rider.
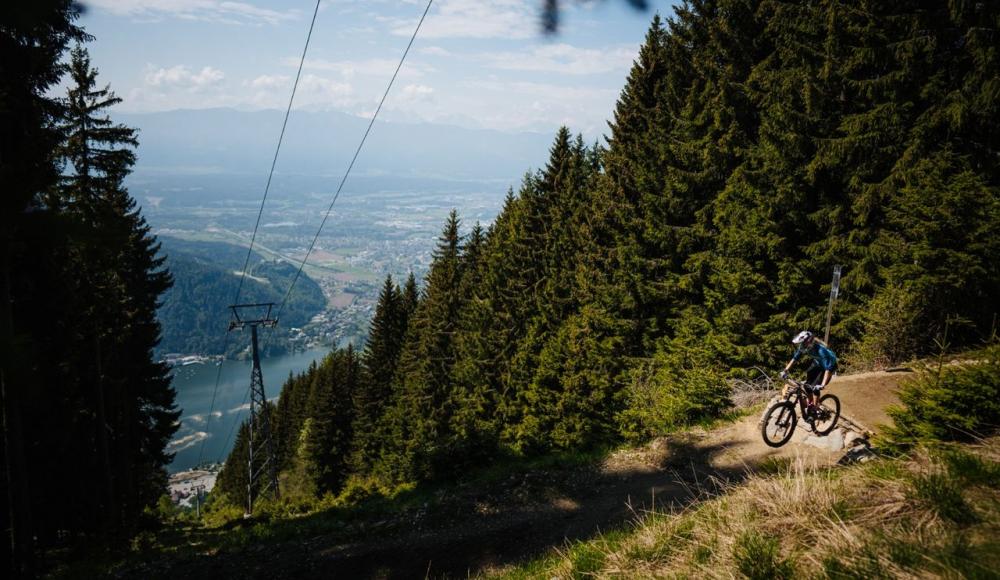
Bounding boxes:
[760,379,840,447]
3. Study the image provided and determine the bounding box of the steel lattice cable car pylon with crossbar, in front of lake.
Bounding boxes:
[229,302,281,517]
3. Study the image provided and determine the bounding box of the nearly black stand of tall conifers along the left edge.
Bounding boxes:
[0,0,180,578]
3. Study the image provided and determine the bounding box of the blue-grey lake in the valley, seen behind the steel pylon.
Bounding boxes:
[167,348,330,473]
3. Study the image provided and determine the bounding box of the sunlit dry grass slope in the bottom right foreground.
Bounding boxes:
[495,440,1000,578]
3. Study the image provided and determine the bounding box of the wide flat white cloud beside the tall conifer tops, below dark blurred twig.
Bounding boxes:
[483,44,637,75]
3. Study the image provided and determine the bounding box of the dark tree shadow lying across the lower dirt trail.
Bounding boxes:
[182,440,747,579]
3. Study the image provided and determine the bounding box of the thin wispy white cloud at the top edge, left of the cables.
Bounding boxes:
[88,0,300,24]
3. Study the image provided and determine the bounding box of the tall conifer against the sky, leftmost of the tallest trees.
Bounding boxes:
[589,15,690,348]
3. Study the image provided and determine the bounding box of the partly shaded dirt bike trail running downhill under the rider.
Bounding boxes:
[166,372,911,578]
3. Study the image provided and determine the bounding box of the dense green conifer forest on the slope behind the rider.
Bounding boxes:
[219,0,1000,505]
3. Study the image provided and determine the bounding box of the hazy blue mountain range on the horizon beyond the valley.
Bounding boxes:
[117,108,553,182]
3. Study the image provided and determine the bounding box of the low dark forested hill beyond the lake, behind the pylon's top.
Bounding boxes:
[157,238,326,356]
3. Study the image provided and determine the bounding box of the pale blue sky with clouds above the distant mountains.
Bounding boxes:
[81,0,672,137]
